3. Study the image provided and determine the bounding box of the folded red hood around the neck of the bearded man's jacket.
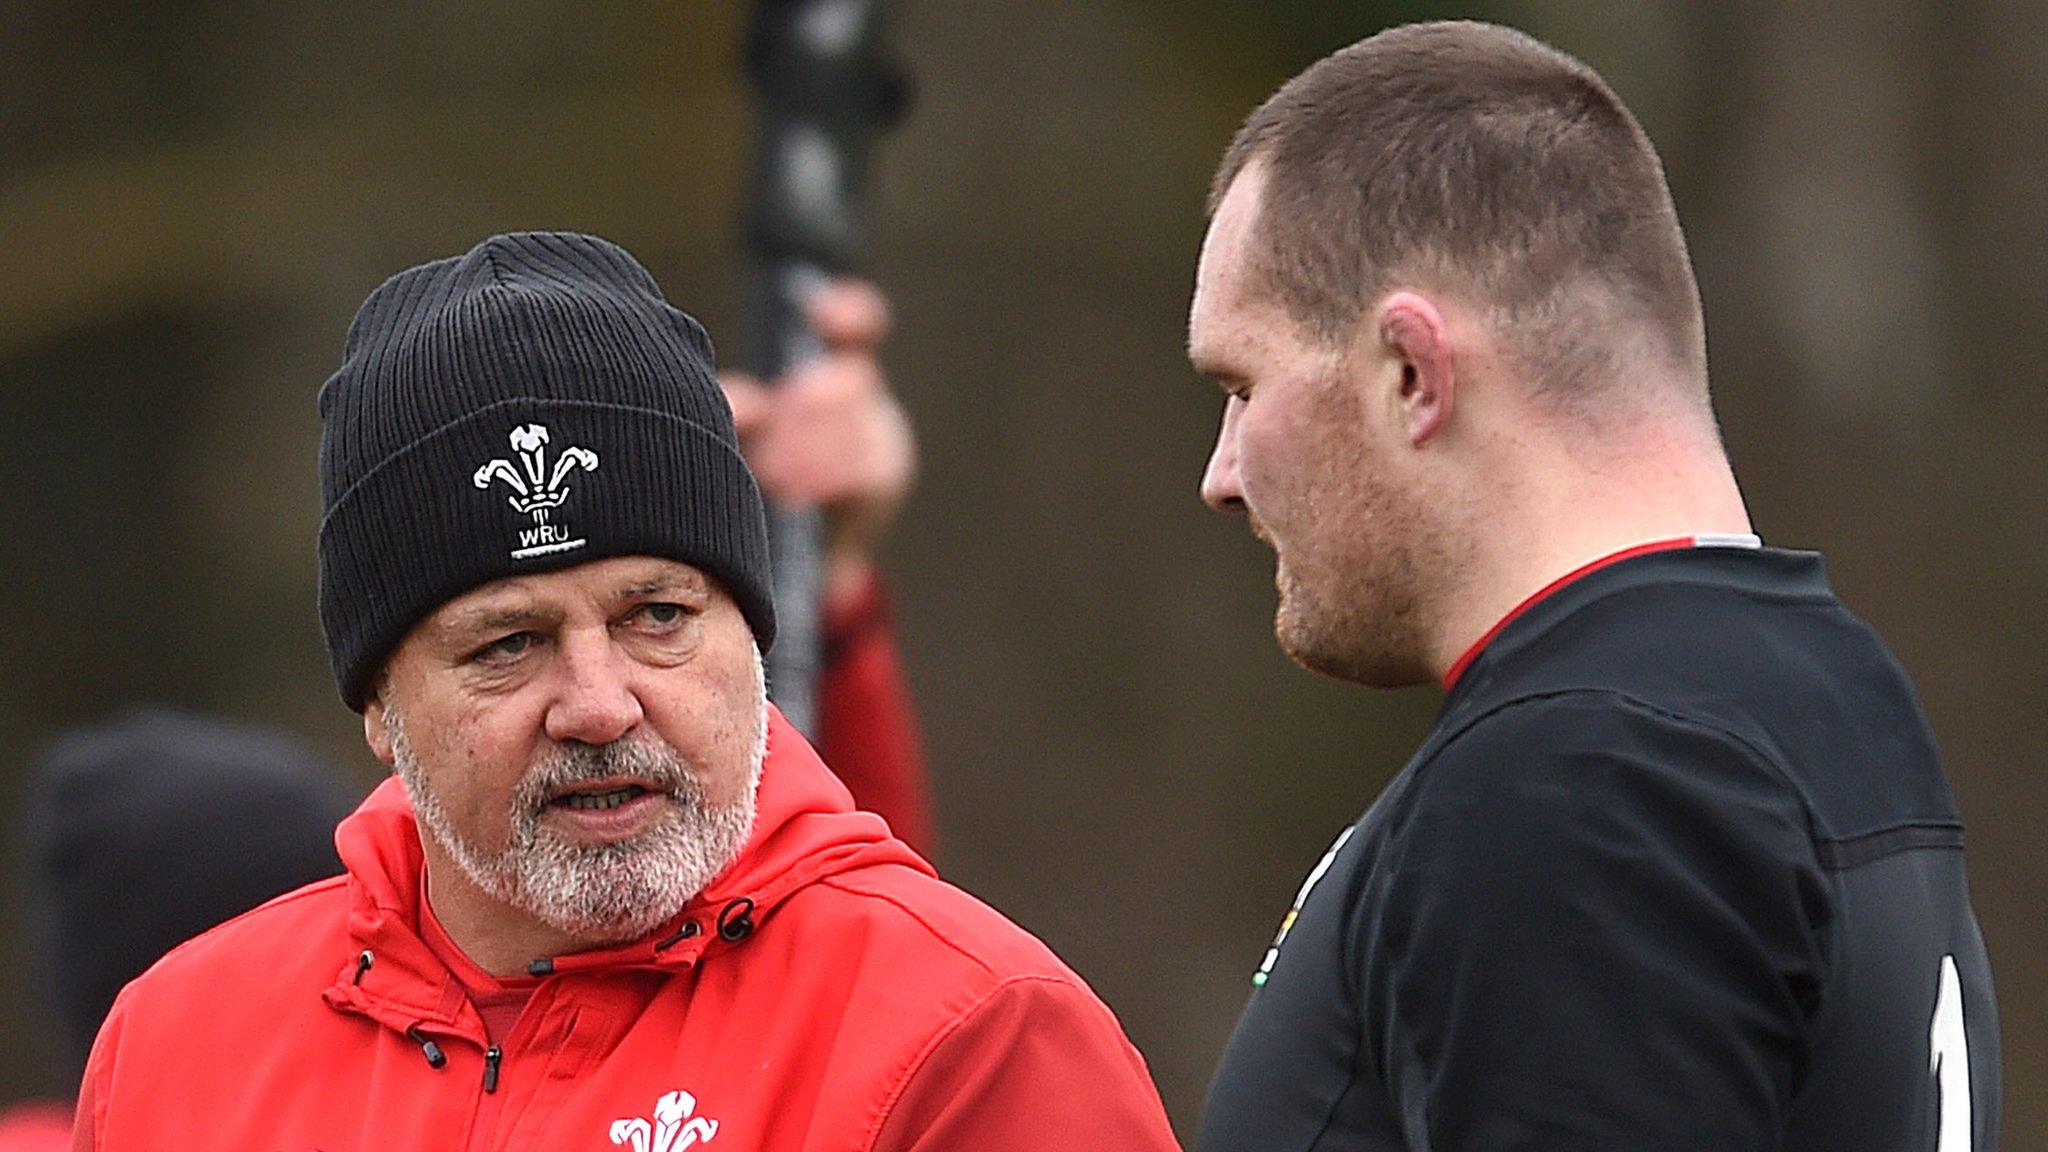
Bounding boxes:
[326,705,936,1031]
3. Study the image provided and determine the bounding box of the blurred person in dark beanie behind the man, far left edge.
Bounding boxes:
[0,707,356,1152]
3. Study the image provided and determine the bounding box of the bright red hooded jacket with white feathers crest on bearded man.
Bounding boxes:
[74,715,1176,1152]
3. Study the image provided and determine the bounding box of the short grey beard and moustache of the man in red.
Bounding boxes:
[385,672,768,947]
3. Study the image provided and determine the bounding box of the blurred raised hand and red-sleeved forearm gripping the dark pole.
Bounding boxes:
[719,281,938,859]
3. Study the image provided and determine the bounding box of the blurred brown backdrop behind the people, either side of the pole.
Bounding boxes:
[0,0,2048,1152]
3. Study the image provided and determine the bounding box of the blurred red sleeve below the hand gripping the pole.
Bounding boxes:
[817,576,938,859]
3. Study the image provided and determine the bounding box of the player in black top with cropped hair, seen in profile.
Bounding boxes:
[1188,23,2001,1152]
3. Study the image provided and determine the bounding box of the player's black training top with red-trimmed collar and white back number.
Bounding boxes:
[1196,547,1999,1152]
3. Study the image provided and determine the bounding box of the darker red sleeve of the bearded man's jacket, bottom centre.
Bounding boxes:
[870,976,1180,1152]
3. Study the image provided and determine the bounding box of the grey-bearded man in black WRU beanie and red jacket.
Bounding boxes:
[76,234,1176,1152]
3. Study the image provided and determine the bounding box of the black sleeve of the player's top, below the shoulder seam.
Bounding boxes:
[1350,693,1829,1152]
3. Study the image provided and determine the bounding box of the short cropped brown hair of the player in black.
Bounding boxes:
[1208,20,1706,398]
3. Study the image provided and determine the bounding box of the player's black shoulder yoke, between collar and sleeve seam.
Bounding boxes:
[1452,549,1956,838]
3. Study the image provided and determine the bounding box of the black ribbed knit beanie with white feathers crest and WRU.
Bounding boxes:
[319,232,774,711]
